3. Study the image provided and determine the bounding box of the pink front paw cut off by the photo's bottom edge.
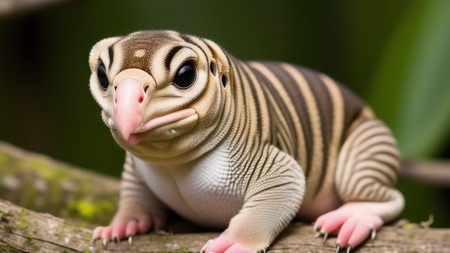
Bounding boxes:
[200,232,253,253]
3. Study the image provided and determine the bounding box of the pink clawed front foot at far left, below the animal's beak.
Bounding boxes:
[92,214,165,247]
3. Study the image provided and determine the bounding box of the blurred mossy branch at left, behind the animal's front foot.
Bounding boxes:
[0,142,119,225]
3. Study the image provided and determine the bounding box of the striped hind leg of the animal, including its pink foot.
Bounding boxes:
[315,120,404,251]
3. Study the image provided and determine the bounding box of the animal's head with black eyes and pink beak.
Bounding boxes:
[89,31,232,163]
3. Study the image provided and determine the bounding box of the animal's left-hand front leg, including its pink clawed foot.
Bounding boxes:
[92,153,166,245]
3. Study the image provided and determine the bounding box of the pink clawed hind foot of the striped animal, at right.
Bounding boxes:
[314,209,383,252]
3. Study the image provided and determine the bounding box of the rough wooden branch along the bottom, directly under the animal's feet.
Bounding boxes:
[0,201,450,253]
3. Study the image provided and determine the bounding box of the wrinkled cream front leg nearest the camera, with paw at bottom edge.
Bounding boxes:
[202,148,305,253]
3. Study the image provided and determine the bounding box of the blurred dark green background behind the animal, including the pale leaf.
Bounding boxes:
[0,0,450,227]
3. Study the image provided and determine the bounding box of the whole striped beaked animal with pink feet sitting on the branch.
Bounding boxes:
[89,31,404,253]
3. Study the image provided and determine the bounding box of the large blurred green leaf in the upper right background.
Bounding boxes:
[368,0,450,158]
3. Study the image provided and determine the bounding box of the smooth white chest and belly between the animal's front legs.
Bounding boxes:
[135,143,243,228]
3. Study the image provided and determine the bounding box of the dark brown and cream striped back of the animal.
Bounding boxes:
[229,60,373,198]
